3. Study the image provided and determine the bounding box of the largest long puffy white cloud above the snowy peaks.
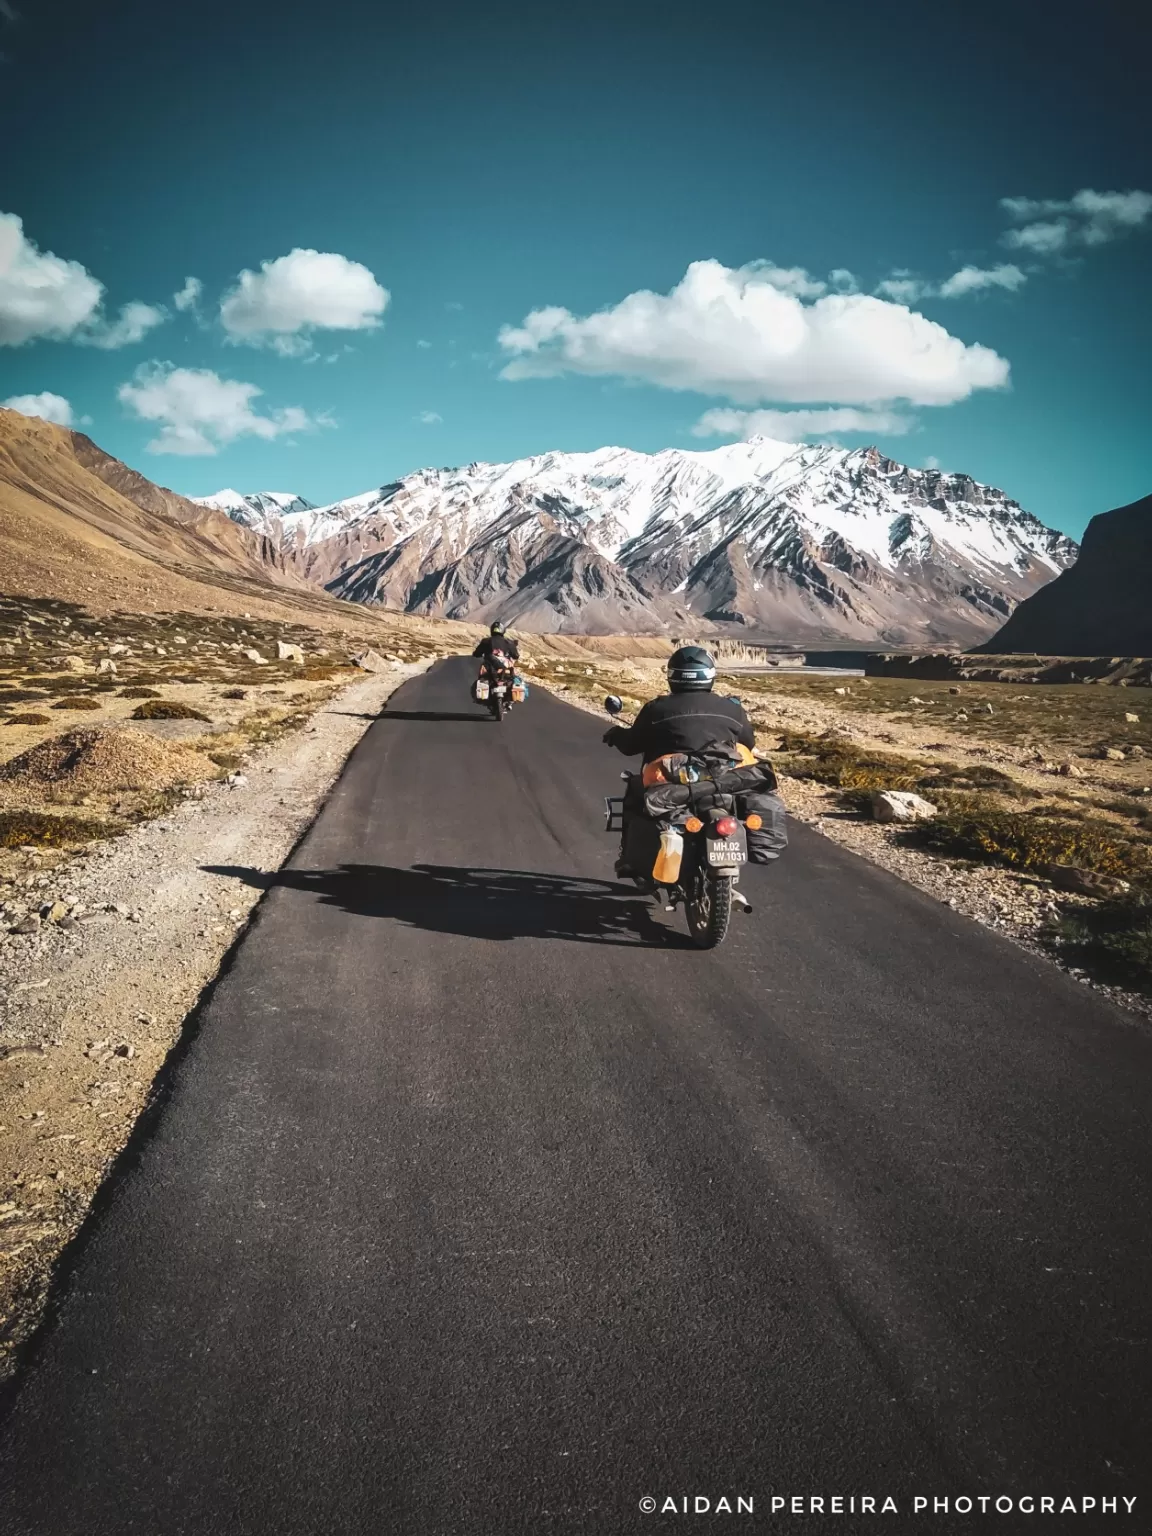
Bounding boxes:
[499,261,1009,406]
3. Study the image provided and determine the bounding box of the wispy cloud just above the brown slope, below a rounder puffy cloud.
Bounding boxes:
[117,362,322,456]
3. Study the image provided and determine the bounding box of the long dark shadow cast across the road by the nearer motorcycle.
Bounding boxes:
[204,865,690,949]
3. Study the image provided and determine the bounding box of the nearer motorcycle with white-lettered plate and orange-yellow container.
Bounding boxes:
[604,694,762,949]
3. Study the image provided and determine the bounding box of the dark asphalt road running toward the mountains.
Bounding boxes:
[0,662,1152,1536]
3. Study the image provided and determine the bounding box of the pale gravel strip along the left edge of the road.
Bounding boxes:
[0,662,429,1378]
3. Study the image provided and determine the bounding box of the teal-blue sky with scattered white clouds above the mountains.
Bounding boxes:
[0,0,1152,535]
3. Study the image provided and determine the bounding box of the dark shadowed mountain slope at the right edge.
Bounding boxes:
[980,496,1152,656]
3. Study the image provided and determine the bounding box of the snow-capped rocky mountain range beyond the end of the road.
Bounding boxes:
[206,438,1077,645]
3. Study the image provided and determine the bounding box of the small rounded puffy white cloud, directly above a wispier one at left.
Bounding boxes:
[220,250,390,356]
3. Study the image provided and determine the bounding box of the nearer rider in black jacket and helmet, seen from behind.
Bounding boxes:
[604,645,788,879]
